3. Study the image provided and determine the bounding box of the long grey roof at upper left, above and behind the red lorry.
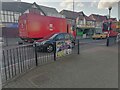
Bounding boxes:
[2,2,60,16]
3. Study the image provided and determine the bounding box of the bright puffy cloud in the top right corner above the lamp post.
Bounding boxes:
[98,0,120,9]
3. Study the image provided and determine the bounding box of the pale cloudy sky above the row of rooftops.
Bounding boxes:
[1,0,120,19]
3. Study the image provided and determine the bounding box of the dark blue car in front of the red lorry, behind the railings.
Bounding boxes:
[34,33,75,52]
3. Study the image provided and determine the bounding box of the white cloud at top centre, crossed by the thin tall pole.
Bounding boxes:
[60,0,84,10]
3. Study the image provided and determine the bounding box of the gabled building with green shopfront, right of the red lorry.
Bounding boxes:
[60,10,95,37]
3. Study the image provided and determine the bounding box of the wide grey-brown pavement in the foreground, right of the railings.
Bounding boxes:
[3,44,118,88]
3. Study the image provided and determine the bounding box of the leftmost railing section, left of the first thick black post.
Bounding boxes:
[2,45,36,83]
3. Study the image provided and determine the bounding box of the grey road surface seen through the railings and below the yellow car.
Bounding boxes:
[2,39,106,67]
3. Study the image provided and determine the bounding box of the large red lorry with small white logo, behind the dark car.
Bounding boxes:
[19,13,73,42]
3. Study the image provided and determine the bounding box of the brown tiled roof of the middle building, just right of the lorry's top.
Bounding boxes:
[60,10,84,19]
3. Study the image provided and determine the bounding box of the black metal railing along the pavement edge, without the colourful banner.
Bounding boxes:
[1,40,80,83]
